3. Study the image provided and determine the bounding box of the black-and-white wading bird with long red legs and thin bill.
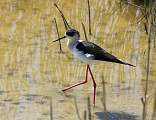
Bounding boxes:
[53,28,135,105]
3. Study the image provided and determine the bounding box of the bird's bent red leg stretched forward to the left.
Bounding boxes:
[62,64,89,92]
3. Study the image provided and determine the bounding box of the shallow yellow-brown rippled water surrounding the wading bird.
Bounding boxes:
[0,0,156,120]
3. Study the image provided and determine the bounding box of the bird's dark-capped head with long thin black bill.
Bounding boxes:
[53,29,80,42]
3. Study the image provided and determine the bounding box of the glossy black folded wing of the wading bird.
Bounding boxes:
[76,41,133,66]
